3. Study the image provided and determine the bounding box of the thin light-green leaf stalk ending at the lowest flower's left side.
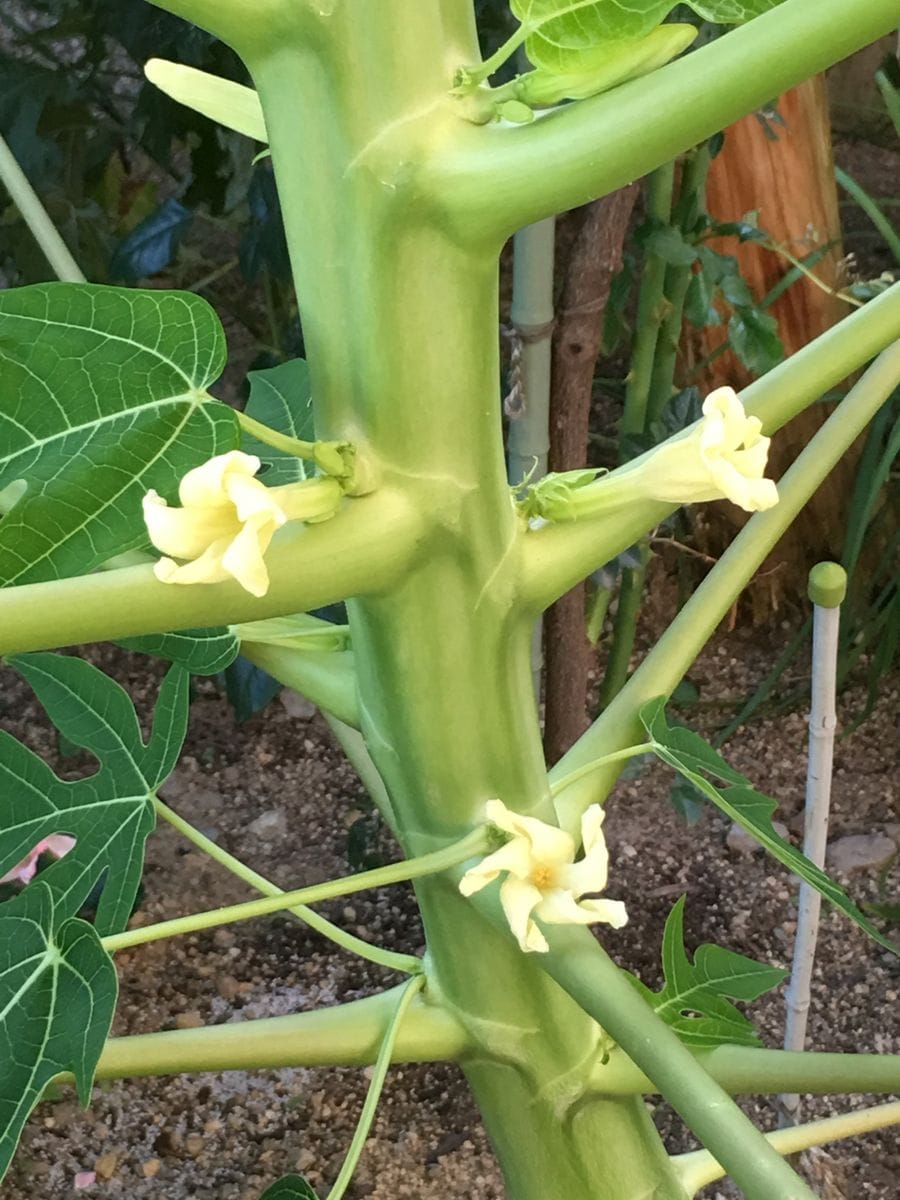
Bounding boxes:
[102,826,492,954]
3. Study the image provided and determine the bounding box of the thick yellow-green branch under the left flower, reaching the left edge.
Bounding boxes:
[0,491,424,654]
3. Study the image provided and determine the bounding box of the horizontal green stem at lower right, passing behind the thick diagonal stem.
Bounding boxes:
[594,1046,900,1096]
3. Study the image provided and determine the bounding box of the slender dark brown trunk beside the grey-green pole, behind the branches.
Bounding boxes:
[544,185,637,763]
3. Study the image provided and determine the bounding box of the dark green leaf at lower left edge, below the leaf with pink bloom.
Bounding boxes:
[0,881,116,1180]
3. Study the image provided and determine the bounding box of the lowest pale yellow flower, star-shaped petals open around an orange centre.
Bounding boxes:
[460,800,628,953]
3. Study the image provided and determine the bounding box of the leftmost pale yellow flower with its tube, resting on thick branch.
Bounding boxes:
[144,450,342,596]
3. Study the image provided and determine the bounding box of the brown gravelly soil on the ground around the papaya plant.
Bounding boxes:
[0,635,900,1200]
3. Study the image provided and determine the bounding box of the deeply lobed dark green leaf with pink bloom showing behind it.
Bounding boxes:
[0,653,188,934]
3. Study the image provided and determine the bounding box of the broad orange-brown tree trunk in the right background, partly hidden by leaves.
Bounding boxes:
[689,77,853,620]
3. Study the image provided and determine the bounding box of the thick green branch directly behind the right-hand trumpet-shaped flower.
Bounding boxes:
[521,284,900,611]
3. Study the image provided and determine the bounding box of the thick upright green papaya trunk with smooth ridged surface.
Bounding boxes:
[252,11,684,1200]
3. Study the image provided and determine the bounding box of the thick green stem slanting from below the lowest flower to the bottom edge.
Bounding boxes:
[539,926,815,1200]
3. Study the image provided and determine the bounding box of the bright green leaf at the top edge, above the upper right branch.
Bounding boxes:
[510,0,781,73]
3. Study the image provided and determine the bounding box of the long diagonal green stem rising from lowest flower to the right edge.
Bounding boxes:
[551,341,900,828]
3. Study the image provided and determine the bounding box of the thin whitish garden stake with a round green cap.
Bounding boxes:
[779,563,847,1123]
